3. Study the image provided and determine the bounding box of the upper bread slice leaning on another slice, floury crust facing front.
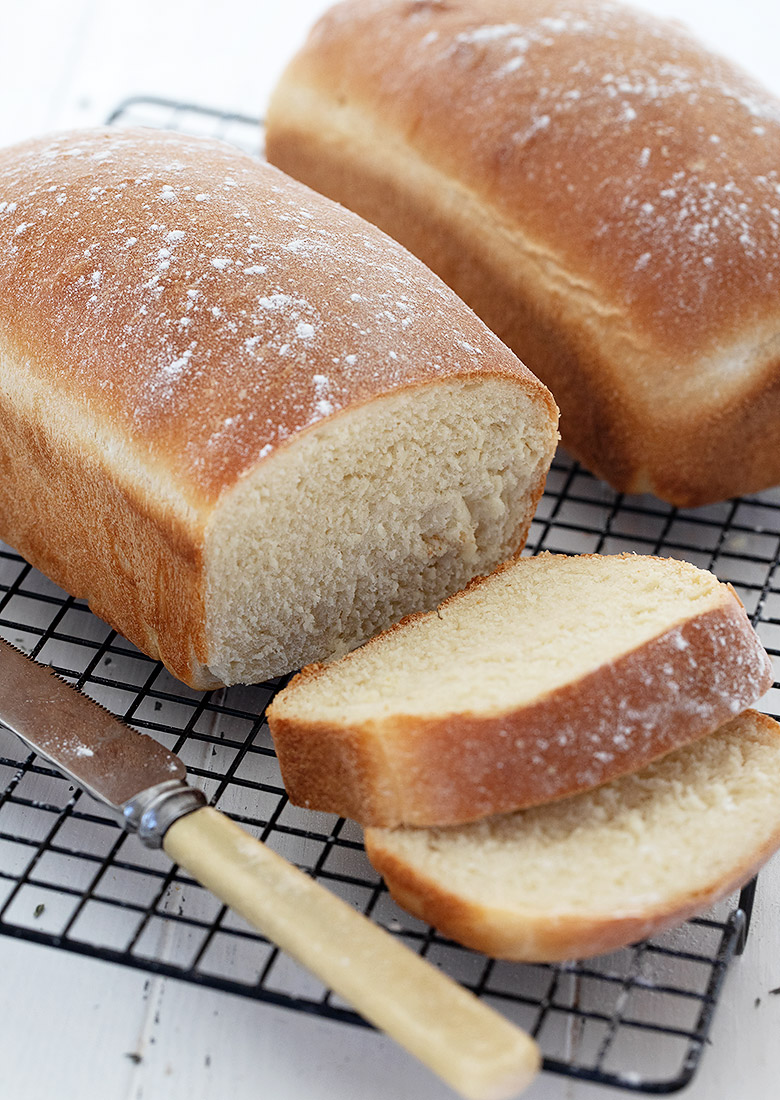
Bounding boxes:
[268,554,772,826]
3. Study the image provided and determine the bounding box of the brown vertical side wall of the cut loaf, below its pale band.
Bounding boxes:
[0,367,217,689]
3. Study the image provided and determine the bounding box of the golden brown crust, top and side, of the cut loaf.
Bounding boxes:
[0,130,557,688]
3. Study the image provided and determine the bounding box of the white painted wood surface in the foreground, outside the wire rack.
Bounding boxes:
[0,860,780,1100]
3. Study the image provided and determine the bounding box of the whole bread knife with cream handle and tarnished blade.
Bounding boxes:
[0,639,540,1100]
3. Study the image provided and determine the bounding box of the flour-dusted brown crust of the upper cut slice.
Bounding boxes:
[268,567,772,827]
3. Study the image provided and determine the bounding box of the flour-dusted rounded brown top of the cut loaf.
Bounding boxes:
[0,129,545,507]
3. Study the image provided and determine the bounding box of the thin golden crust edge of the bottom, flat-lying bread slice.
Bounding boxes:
[365,711,780,963]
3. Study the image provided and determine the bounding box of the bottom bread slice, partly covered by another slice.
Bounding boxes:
[365,711,780,961]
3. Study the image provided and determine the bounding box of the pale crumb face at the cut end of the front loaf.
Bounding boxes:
[201,377,557,684]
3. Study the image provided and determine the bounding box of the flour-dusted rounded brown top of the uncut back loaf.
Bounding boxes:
[290,0,780,356]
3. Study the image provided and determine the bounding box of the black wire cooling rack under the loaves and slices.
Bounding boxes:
[0,99,780,1093]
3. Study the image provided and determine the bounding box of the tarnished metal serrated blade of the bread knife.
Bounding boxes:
[0,639,186,815]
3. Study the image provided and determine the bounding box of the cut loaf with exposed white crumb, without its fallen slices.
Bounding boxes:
[0,130,557,688]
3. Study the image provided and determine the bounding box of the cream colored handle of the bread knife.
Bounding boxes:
[163,806,540,1100]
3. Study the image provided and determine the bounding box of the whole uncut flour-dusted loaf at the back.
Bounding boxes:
[267,0,780,506]
